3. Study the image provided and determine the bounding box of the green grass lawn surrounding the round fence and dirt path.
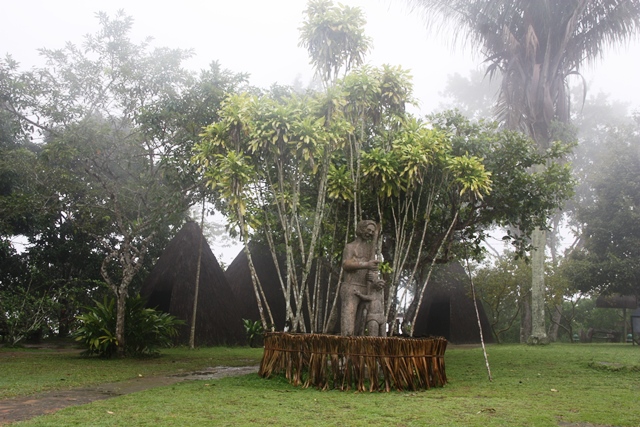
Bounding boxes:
[0,344,640,427]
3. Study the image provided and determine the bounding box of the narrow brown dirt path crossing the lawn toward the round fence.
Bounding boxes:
[0,366,258,426]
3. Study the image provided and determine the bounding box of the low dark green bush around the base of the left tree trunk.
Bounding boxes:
[73,295,184,358]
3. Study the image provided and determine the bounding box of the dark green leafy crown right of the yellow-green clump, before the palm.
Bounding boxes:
[430,111,574,255]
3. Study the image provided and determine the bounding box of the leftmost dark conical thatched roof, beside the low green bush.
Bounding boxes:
[140,222,245,346]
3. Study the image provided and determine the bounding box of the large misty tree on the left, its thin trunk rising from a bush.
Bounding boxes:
[0,13,245,354]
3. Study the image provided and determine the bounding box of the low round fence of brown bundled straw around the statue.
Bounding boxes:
[258,332,447,392]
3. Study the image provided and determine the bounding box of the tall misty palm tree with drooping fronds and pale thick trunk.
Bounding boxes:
[405,0,640,343]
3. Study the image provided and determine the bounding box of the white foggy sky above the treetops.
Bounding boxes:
[0,0,640,263]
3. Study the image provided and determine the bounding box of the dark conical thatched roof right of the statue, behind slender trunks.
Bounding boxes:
[414,262,494,344]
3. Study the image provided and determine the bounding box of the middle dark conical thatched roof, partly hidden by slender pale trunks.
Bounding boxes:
[224,242,286,331]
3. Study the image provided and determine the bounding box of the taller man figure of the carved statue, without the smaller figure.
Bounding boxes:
[340,220,380,336]
